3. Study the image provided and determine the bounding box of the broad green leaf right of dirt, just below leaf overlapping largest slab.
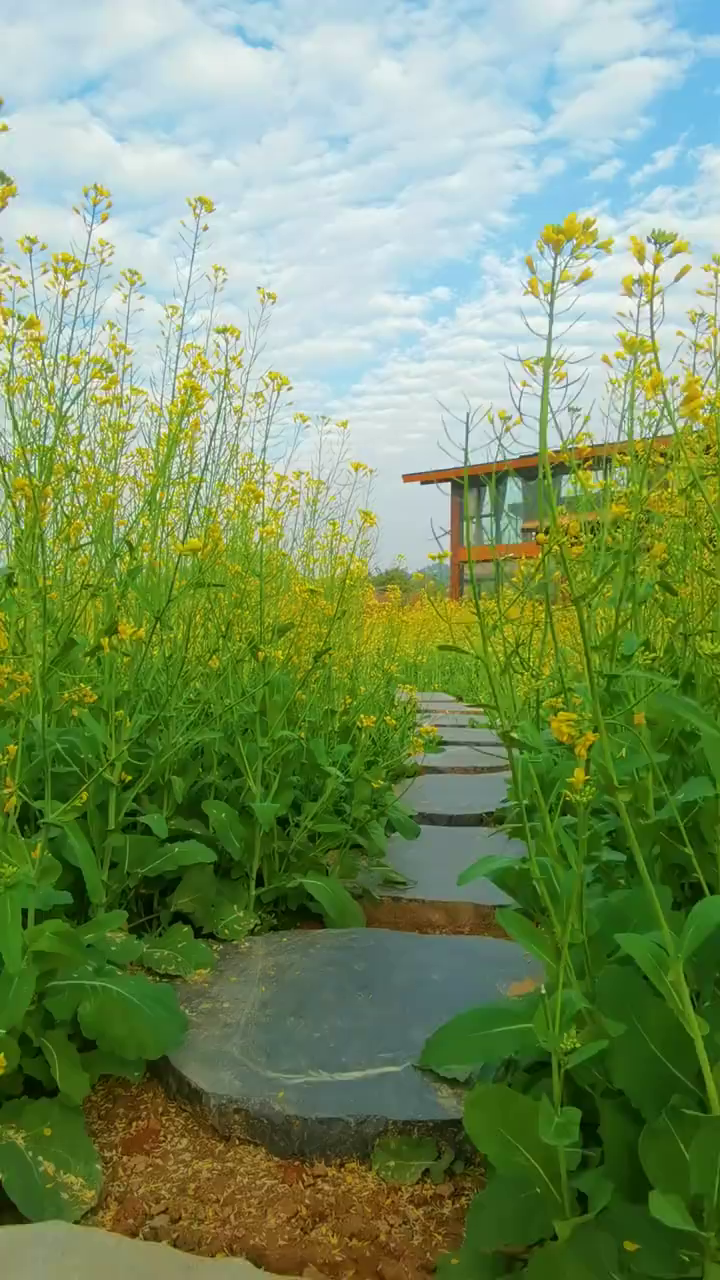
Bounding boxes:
[464,1084,562,1215]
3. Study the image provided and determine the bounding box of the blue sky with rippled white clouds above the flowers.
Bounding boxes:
[0,0,720,567]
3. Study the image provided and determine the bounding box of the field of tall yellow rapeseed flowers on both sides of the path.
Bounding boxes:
[7,99,720,1280]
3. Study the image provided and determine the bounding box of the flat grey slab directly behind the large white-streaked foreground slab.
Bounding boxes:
[378,827,525,906]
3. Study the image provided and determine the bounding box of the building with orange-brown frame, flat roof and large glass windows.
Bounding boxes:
[402,436,671,599]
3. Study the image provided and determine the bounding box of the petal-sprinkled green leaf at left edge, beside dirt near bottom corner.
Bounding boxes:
[0,1098,102,1222]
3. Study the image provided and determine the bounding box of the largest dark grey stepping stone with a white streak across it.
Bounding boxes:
[164,929,538,1157]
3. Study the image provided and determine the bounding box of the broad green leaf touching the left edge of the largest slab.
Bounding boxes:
[46,966,187,1059]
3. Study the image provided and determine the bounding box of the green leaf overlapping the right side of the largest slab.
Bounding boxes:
[418,996,538,1079]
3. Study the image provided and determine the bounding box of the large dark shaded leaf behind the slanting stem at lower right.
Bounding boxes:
[596,965,701,1120]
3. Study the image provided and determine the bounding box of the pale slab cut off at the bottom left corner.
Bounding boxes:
[0,1222,289,1280]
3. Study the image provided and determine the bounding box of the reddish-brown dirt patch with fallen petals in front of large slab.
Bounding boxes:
[86,1079,480,1280]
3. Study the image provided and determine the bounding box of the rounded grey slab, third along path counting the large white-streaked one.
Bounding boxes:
[395,772,511,827]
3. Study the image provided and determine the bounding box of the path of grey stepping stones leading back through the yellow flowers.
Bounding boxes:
[164,694,530,1157]
